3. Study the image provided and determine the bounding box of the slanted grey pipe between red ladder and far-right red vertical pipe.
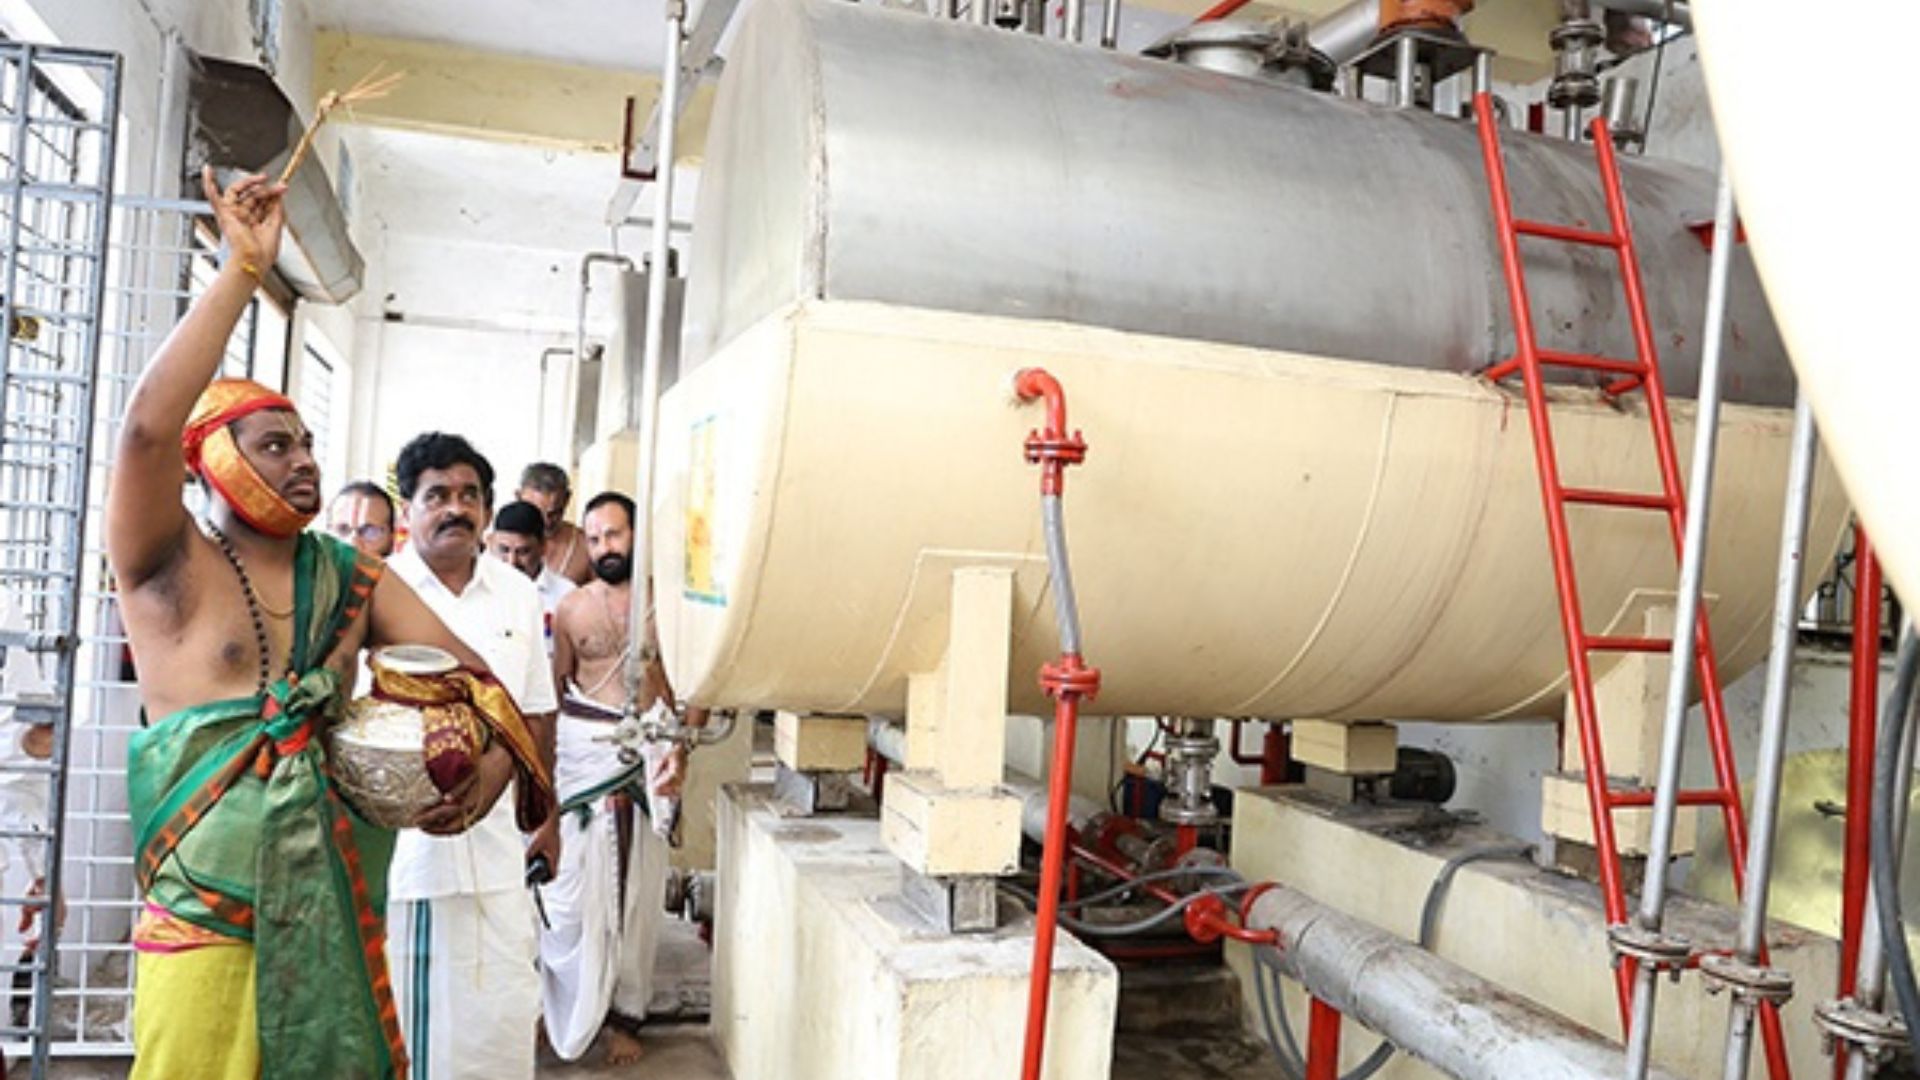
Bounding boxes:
[1715,393,1818,1080]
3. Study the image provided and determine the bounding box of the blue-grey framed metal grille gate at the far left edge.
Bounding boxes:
[0,42,119,1076]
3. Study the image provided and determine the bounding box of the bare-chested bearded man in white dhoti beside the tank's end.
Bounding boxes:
[540,492,707,1065]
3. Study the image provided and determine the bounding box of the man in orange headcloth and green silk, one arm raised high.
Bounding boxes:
[106,166,551,1080]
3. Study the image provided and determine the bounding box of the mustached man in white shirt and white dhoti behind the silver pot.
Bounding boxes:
[374,432,559,1080]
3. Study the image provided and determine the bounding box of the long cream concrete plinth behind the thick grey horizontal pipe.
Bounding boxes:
[1227,788,1839,1080]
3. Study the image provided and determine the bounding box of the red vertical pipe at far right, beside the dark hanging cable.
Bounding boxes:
[1834,525,1880,1076]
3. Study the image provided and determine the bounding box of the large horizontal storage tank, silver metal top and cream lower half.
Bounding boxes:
[653,0,1845,721]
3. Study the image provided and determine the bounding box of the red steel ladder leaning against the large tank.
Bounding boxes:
[1473,92,1788,1080]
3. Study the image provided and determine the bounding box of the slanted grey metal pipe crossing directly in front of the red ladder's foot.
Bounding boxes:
[1626,165,1734,1080]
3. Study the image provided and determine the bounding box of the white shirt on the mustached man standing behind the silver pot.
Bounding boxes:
[386,546,559,899]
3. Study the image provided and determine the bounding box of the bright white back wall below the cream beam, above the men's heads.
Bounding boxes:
[342,125,693,494]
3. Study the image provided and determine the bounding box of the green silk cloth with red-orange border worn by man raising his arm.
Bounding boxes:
[127,532,407,1080]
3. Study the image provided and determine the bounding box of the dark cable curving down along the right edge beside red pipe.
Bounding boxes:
[1864,625,1920,1032]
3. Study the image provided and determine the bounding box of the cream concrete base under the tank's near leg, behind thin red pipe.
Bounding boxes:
[712,780,1119,1080]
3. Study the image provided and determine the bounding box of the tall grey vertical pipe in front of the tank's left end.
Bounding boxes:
[626,0,687,717]
